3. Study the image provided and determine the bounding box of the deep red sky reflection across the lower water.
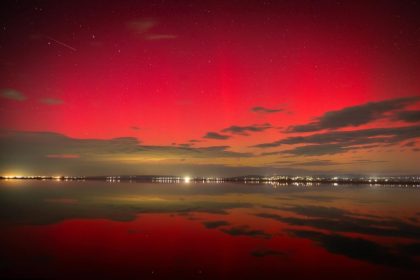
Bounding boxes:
[0,210,418,279]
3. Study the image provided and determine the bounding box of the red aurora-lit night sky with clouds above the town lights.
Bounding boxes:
[0,1,420,176]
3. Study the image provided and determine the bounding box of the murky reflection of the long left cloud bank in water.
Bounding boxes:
[0,192,252,225]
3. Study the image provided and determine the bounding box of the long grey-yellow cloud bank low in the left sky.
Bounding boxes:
[0,131,252,172]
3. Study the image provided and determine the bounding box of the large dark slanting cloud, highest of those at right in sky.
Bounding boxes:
[288,97,420,132]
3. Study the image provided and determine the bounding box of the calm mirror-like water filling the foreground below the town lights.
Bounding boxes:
[0,181,420,280]
